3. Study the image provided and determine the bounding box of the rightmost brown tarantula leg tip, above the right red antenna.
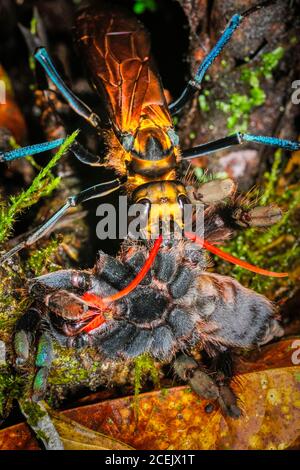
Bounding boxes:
[233,206,282,228]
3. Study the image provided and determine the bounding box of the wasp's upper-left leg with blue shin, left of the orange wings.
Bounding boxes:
[19,25,100,129]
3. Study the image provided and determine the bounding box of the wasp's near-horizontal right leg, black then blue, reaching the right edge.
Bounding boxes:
[182,132,300,160]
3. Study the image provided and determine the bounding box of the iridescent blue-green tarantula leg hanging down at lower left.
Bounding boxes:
[32,333,53,402]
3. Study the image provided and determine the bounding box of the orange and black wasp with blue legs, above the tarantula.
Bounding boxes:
[0,0,300,262]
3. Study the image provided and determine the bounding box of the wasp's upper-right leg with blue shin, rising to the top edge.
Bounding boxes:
[169,0,275,115]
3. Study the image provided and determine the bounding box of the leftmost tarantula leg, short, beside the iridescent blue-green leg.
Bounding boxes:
[14,308,41,366]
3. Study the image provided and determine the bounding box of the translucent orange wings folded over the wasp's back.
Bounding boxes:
[76,6,172,133]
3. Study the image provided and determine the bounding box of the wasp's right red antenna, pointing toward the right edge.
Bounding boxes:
[184,232,289,277]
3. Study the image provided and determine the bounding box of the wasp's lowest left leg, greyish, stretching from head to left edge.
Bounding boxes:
[0,178,124,264]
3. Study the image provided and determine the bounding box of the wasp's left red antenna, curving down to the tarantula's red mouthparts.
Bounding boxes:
[81,235,162,332]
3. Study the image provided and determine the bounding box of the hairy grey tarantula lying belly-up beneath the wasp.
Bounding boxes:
[14,181,282,417]
